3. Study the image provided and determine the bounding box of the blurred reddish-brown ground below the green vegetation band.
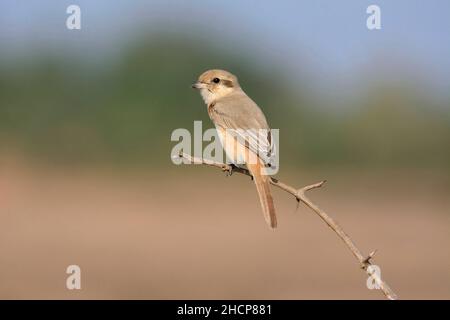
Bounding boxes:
[0,158,450,299]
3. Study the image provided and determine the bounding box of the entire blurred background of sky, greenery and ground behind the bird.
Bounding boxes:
[0,0,450,299]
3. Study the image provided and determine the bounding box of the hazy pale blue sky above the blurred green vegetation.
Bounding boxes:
[0,0,450,102]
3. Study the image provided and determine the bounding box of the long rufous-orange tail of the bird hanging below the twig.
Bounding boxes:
[247,163,277,229]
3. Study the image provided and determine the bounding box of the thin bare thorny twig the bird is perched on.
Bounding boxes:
[175,153,398,300]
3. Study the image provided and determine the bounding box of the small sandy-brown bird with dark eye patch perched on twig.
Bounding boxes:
[192,69,277,229]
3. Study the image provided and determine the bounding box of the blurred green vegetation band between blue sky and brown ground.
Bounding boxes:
[0,35,450,170]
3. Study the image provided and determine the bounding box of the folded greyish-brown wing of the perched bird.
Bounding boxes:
[210,92,275,165]
